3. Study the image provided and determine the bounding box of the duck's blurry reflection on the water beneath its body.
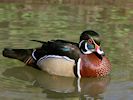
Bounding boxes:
[3,66,110,100]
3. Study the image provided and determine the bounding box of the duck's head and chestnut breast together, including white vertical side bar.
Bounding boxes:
[77,30,111,77]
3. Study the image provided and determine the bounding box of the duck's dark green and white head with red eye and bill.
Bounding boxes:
[79,30,104,55]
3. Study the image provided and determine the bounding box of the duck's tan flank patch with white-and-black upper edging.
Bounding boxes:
[37,55,75,77]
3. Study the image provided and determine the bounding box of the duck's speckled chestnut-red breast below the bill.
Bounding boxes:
[80,53,111,77]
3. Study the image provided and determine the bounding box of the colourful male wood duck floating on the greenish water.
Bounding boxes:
[3,30,111,78]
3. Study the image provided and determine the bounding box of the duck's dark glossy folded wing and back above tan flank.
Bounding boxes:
[34,40,81,61]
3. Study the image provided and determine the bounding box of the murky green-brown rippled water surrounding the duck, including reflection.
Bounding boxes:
[0,0,133,100]
